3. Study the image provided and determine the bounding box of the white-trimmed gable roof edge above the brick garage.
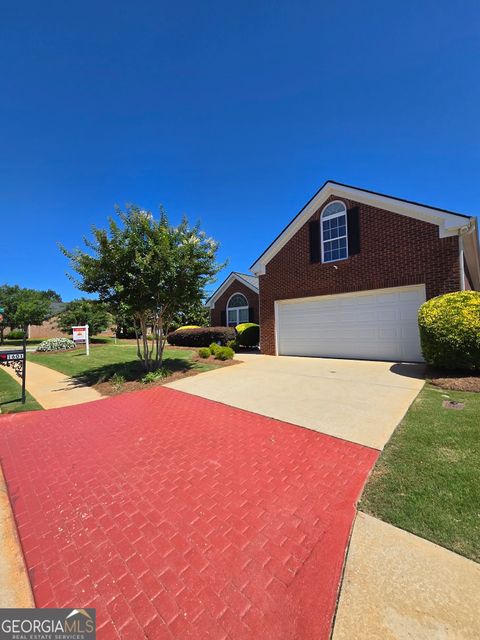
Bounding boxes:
[250,180,471,276]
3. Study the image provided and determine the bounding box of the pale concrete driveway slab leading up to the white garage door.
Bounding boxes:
[167,355,423,449]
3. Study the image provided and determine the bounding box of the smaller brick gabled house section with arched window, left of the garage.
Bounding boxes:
[207,271,258,327]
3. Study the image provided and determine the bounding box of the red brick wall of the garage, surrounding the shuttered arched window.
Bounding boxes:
[260,197,460,355]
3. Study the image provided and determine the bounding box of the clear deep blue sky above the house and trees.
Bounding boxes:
[0,0,480,300]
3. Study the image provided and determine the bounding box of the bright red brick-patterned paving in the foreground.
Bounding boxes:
[0,388,378,640]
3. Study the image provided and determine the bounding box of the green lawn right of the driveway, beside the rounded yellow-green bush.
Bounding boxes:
[360,385,480,562]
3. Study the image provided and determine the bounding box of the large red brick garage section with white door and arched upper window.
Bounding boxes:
[251,181,480,361]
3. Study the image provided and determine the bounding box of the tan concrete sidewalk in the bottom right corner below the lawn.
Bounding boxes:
[332,512,480,640]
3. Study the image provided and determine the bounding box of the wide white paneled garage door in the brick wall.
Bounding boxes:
[275,285,425,362]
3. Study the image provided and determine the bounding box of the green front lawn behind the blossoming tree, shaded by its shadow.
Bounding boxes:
[27,344,212,385]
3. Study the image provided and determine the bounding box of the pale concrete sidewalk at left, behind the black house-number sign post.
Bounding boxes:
[3,361,104,409]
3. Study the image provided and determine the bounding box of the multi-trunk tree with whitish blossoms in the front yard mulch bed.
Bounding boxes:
[60,205,223,370]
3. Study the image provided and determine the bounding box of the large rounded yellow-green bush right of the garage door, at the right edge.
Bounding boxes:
[418,291,480,371]
